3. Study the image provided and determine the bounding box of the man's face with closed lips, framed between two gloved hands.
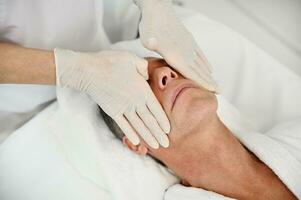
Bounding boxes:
[126,58,217,154]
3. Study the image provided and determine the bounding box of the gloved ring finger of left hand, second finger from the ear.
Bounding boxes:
[125,112,159,149]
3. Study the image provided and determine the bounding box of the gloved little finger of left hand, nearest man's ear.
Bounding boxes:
[115,116,140,145]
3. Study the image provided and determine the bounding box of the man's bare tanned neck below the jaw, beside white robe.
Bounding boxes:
[154,115,295,199]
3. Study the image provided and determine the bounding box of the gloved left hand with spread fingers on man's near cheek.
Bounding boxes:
[54,49,170,148]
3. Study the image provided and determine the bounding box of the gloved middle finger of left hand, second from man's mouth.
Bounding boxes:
[137,106,169,148]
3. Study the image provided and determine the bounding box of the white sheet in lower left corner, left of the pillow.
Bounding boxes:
[0,103,111,200]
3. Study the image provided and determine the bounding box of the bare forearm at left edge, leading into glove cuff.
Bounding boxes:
[0,42,56,85]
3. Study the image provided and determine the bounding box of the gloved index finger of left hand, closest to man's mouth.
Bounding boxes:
[146,93,170,134]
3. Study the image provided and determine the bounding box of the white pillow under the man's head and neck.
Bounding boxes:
[51,89,178,200]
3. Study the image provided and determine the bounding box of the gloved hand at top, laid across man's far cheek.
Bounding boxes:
[134,0,217,91]
